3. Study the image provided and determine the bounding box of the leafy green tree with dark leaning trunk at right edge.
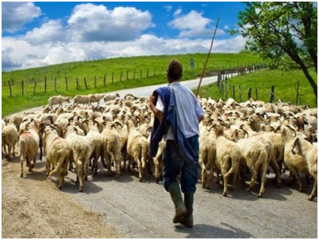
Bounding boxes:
[231,2,318,99]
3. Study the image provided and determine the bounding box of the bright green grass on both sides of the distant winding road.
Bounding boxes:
[2,53,317,117]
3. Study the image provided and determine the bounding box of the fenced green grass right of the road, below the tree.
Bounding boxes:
[199,69,317,107]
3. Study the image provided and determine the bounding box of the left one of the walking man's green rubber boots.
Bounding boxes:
[168,183,187,223]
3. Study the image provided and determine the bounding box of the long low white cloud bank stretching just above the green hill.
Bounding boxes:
[2,34,245,71]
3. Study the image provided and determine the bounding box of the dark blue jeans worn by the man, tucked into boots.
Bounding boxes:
[163,136,199,193]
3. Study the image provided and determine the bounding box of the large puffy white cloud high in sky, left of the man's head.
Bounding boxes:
[68,3,154,42]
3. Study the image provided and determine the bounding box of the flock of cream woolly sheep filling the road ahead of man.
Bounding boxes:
[2,93,317,200]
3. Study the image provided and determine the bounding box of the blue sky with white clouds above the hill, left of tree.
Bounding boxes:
[2,1,245,71]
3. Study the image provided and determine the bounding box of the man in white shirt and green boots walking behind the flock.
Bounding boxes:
[149,60,204,227]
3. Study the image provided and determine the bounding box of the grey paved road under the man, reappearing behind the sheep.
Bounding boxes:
[11,77,318,238]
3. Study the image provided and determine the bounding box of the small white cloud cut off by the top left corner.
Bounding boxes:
[2,2,41,33]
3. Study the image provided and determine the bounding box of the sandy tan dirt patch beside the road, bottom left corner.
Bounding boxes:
[2,157,119,238]
